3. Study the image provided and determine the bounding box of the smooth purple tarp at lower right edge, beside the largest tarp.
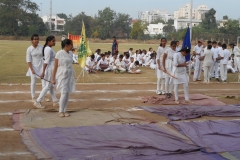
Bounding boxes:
[169,121,240,153]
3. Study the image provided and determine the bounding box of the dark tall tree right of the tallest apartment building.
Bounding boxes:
[201,8,217,31]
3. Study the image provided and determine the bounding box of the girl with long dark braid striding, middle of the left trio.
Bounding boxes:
[34,36,59,109]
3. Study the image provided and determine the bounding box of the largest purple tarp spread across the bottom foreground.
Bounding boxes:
[21,124,211,160]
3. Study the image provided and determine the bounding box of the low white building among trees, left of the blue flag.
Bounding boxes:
[144,23,166,36]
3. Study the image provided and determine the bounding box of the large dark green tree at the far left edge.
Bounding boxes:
[0,0,39,36]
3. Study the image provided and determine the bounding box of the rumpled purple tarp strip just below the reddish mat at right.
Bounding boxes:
[139,105,240,121]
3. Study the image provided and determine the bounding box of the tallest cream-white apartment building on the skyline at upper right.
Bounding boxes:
[174,4,210,20]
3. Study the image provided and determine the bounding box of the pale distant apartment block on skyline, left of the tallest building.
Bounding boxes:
[138,10,173,24]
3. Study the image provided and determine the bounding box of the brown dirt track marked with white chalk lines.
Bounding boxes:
[0,83,240,160]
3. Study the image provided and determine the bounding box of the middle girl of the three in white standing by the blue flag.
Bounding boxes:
[163,41,177,98]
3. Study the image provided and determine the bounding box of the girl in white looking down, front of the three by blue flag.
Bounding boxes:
[173,47,191,104]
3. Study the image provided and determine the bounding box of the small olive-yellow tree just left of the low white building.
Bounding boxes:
[130,21,147,39]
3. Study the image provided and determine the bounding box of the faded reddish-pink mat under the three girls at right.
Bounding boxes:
[139,94,226,106]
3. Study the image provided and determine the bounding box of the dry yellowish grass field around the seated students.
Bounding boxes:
[0,40,237,83]
